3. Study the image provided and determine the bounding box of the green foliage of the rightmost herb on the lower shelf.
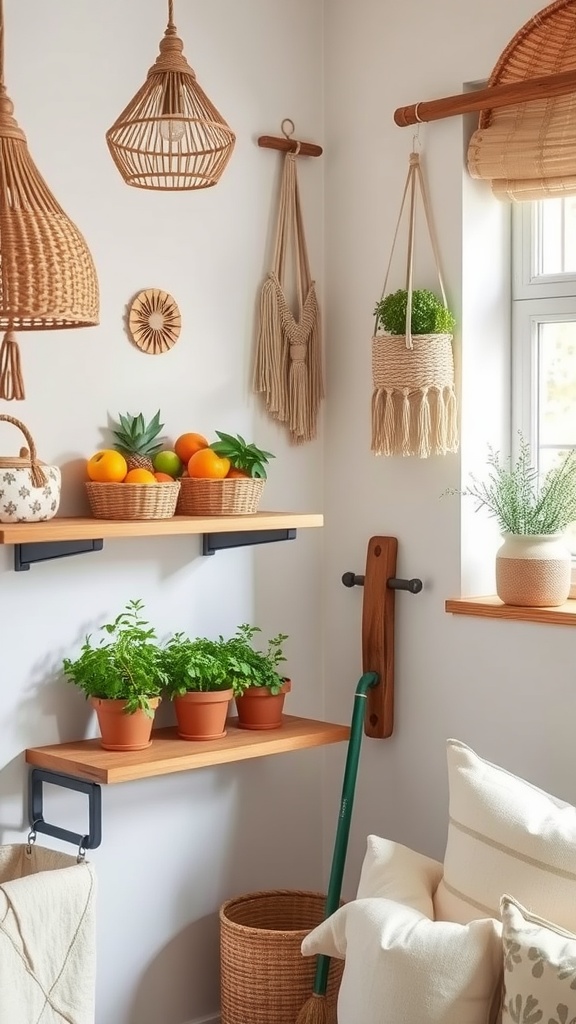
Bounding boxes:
[220,623,288,696]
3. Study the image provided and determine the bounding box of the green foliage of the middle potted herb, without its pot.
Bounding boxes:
[162,633,232,700]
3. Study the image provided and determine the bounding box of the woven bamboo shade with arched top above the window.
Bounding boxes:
[467,0,576,201]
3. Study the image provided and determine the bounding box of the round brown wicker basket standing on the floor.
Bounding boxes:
[220,890,338,1024]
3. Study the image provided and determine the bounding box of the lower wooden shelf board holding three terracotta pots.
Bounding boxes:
[26,715,349,784]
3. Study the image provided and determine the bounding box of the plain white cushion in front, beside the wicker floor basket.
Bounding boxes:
[301,898,502,1024]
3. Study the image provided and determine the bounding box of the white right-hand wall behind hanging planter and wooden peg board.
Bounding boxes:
[324,0,576,895]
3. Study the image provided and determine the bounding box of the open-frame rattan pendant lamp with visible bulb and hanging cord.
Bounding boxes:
[106,0,236,191]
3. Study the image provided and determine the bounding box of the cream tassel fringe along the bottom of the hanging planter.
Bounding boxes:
[372,387,458,459]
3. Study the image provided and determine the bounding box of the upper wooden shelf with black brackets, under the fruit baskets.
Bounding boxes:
[0,512,324,571]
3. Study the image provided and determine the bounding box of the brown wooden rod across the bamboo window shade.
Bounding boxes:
[394,71,576,128]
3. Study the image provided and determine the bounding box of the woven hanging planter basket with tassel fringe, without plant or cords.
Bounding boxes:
[372,334,458,459]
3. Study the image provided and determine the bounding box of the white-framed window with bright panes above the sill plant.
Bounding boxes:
[512,197,576,557]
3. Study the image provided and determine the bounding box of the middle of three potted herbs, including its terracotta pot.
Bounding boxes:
[162,633,233,739]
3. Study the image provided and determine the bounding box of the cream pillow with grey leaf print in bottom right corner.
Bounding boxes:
[500,896,576,1024]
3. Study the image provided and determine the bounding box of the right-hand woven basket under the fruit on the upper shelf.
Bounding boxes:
[176,476,265,515]
